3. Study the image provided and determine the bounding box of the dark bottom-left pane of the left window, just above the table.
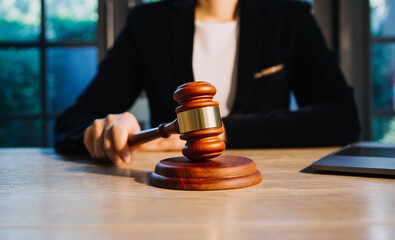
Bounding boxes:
[0,119,43,147]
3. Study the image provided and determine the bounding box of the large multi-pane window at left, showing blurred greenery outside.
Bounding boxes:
[0,0,98,147]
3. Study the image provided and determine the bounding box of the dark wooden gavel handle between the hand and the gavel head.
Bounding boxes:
[128,119,180,146]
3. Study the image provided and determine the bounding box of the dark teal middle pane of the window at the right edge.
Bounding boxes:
[372,43,395,110]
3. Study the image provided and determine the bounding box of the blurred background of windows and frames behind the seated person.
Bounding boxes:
[0,0,395,147]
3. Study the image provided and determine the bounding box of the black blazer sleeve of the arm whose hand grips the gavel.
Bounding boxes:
[54,11,142,154]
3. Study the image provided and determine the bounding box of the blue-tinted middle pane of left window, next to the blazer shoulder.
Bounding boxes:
[47,47,97,113]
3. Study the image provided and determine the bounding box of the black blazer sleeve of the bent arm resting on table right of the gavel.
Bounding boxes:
[223,9,360,148]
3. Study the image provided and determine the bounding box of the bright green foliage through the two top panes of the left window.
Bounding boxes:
[0,0,98,42]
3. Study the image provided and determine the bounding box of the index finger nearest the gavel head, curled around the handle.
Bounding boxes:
[112,113,140,162]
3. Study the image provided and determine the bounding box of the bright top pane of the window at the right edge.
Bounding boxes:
[370,0,395,37]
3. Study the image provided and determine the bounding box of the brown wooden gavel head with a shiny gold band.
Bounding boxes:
[173,82,225,160]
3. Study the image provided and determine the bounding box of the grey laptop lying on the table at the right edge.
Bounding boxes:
[312,142,395,175]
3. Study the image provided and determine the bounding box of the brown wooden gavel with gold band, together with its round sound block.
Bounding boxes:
[128,82,262,191]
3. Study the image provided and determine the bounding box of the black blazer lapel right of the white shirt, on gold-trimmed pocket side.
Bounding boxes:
[233,0,267,113]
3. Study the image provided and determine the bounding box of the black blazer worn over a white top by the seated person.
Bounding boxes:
[55,0,360,153]
